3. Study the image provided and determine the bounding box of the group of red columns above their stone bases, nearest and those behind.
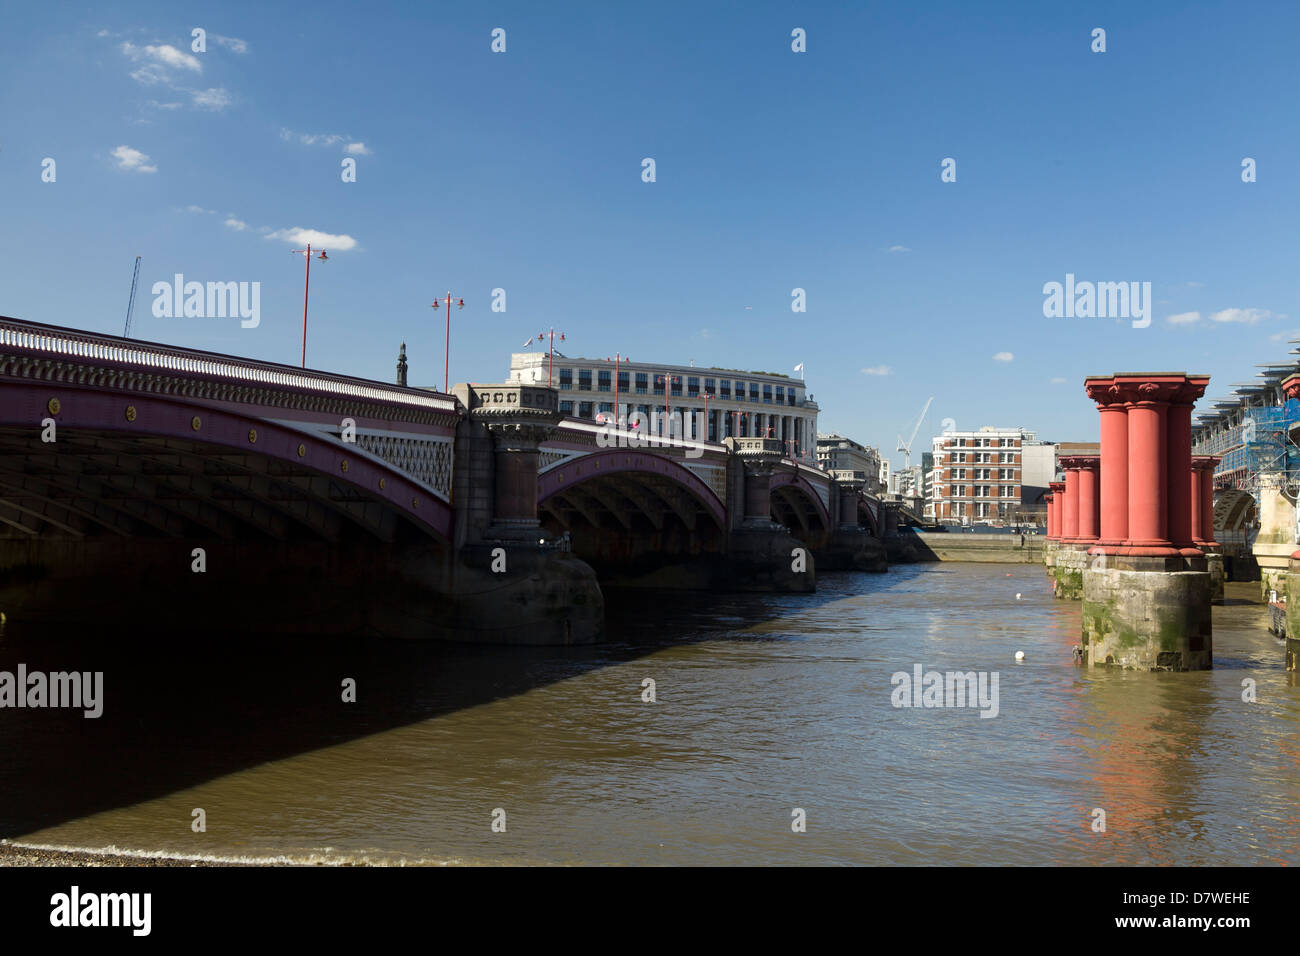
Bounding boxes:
[1045,372,1218,557]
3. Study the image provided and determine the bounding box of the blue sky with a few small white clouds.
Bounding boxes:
[0,0,1300,466]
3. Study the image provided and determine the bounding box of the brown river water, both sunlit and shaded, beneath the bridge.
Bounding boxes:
[0,564,1300,864]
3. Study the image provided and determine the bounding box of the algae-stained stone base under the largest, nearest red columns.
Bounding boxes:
[1083,555,1214,671]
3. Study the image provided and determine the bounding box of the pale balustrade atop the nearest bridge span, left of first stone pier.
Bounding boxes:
[0,317,456,412]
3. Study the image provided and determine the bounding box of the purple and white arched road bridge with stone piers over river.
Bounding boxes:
[0,319,891,644]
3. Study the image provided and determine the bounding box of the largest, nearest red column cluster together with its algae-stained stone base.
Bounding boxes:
[1058,372,1213,671]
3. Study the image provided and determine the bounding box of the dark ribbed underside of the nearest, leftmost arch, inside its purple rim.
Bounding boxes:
[0,428,428,542]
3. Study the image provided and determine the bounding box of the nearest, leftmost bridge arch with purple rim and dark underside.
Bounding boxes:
[0,381,452,545]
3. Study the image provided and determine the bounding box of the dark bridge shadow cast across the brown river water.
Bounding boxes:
[0,568,915,838]
